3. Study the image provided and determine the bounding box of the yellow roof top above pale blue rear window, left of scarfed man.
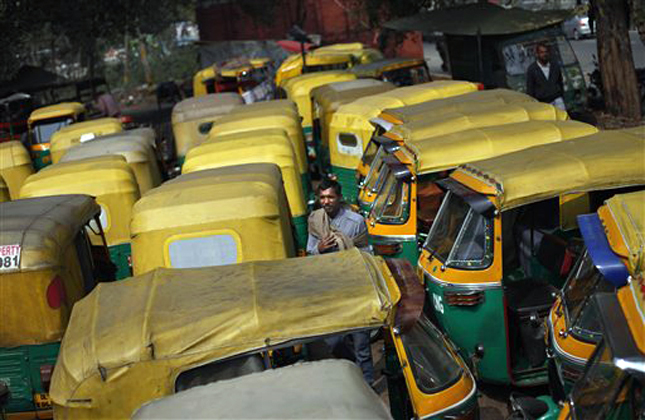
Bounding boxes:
[130,163,289,235]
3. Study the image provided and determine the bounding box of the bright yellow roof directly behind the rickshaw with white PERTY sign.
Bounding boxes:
[20,155,139,197]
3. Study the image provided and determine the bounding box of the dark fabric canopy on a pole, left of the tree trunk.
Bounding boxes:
[383,3,571,36]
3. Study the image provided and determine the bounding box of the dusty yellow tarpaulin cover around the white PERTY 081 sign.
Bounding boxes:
[0,195,100,347]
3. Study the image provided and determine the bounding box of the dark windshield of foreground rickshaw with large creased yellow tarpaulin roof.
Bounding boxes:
[401,316,463,394]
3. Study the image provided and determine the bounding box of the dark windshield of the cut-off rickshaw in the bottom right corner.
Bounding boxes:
[571,340,631,420]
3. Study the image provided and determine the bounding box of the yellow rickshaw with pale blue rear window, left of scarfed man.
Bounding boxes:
[130,163,296,275]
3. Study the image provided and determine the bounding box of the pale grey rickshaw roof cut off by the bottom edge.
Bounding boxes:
[132,360,393,420]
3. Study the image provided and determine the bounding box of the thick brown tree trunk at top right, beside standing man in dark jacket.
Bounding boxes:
[594,0,641,120]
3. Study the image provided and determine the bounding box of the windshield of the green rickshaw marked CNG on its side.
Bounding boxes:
[424,191,493,269]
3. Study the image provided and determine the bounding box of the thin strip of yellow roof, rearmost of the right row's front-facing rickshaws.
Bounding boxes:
[380,89,537,124]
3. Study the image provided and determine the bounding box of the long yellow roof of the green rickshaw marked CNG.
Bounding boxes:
[451,130,645,210]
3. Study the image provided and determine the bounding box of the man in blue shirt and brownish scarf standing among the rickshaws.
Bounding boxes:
[307,178,374,385]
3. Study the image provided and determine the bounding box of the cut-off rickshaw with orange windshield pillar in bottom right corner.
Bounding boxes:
[511,282,645,420]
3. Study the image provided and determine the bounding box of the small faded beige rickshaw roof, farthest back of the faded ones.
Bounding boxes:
[172,92,244,124]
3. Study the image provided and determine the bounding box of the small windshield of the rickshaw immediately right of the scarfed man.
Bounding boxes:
[373,170,410,224]
